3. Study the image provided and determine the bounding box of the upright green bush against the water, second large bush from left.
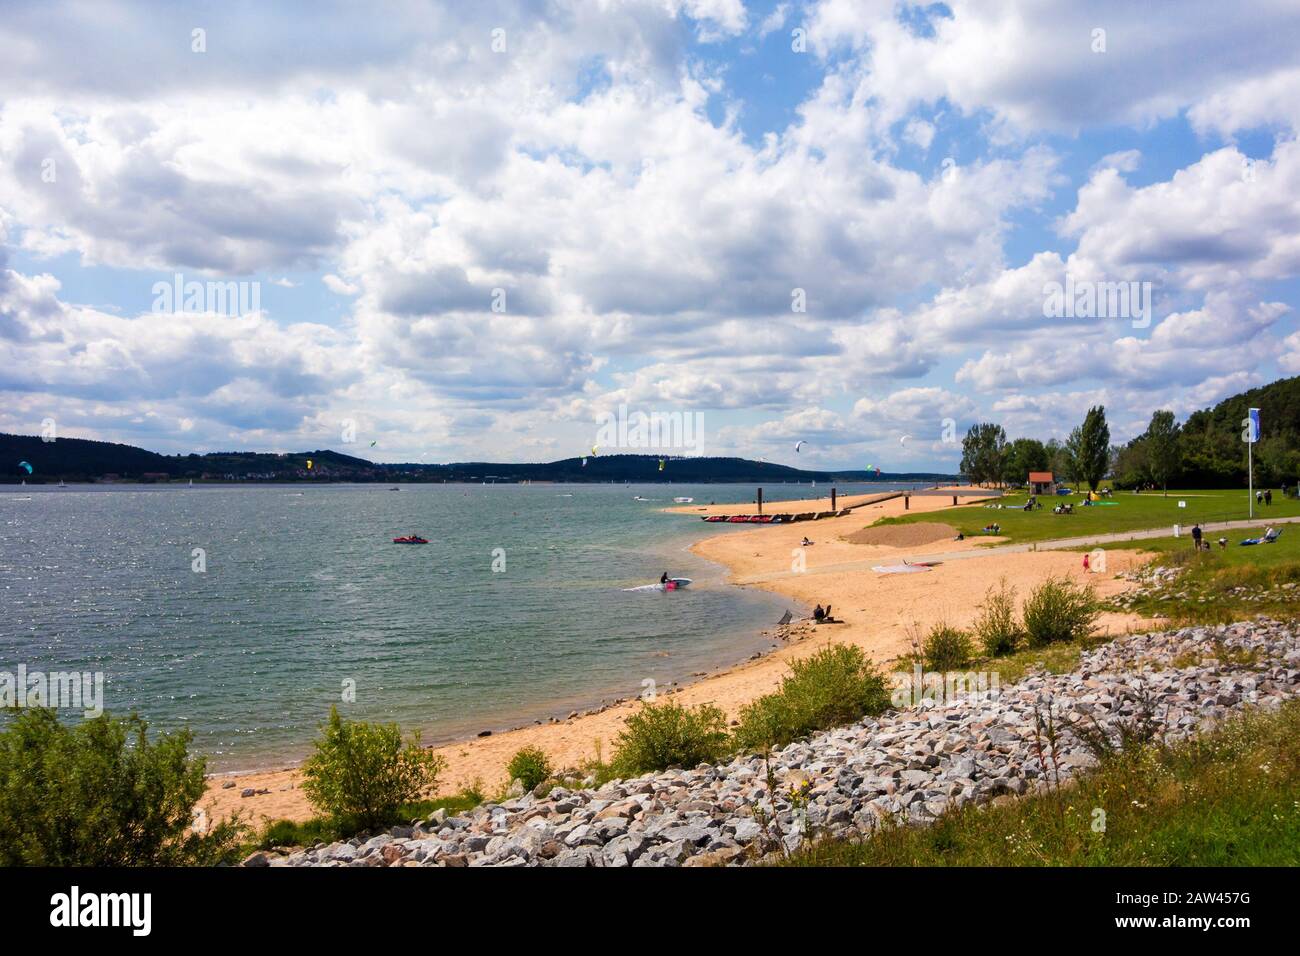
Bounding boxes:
[303,708,446,830]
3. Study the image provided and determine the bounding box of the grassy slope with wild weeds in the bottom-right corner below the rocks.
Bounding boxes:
[776,701,1300,866]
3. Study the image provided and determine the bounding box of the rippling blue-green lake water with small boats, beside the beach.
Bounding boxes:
[0,485,915,770]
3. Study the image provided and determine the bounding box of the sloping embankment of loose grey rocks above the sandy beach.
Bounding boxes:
[246,620,1300,866]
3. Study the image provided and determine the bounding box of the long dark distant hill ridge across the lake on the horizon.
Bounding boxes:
[0,433,954,484]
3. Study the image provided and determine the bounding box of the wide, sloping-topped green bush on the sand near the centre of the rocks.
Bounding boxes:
[736,644,889,749]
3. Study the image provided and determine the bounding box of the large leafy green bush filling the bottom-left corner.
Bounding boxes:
[0,709,244,866]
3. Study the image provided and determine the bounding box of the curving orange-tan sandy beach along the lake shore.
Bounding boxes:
[200,489,1148,822]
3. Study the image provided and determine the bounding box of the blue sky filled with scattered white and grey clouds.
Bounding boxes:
[0,0,1300,472]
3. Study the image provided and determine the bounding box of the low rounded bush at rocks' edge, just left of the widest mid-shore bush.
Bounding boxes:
[611,701,727,777]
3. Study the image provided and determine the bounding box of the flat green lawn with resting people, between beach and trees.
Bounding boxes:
[876,488,1300,551]
